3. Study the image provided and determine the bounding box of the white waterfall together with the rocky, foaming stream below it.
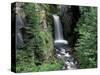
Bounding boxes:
[53,14,77,70]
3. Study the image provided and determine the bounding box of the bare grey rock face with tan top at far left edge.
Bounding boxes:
[12,2,25,48]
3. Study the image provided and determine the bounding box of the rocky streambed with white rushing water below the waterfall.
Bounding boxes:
[56,48,78,70]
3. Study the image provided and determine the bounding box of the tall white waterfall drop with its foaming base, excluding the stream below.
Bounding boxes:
[53,15,68,47]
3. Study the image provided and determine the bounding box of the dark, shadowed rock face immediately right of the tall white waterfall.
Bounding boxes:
[60,5,80,46]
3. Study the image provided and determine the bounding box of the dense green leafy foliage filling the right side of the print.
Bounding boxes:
[75,7,97,68]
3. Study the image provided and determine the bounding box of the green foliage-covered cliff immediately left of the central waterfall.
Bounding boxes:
[16,3,63,72]
